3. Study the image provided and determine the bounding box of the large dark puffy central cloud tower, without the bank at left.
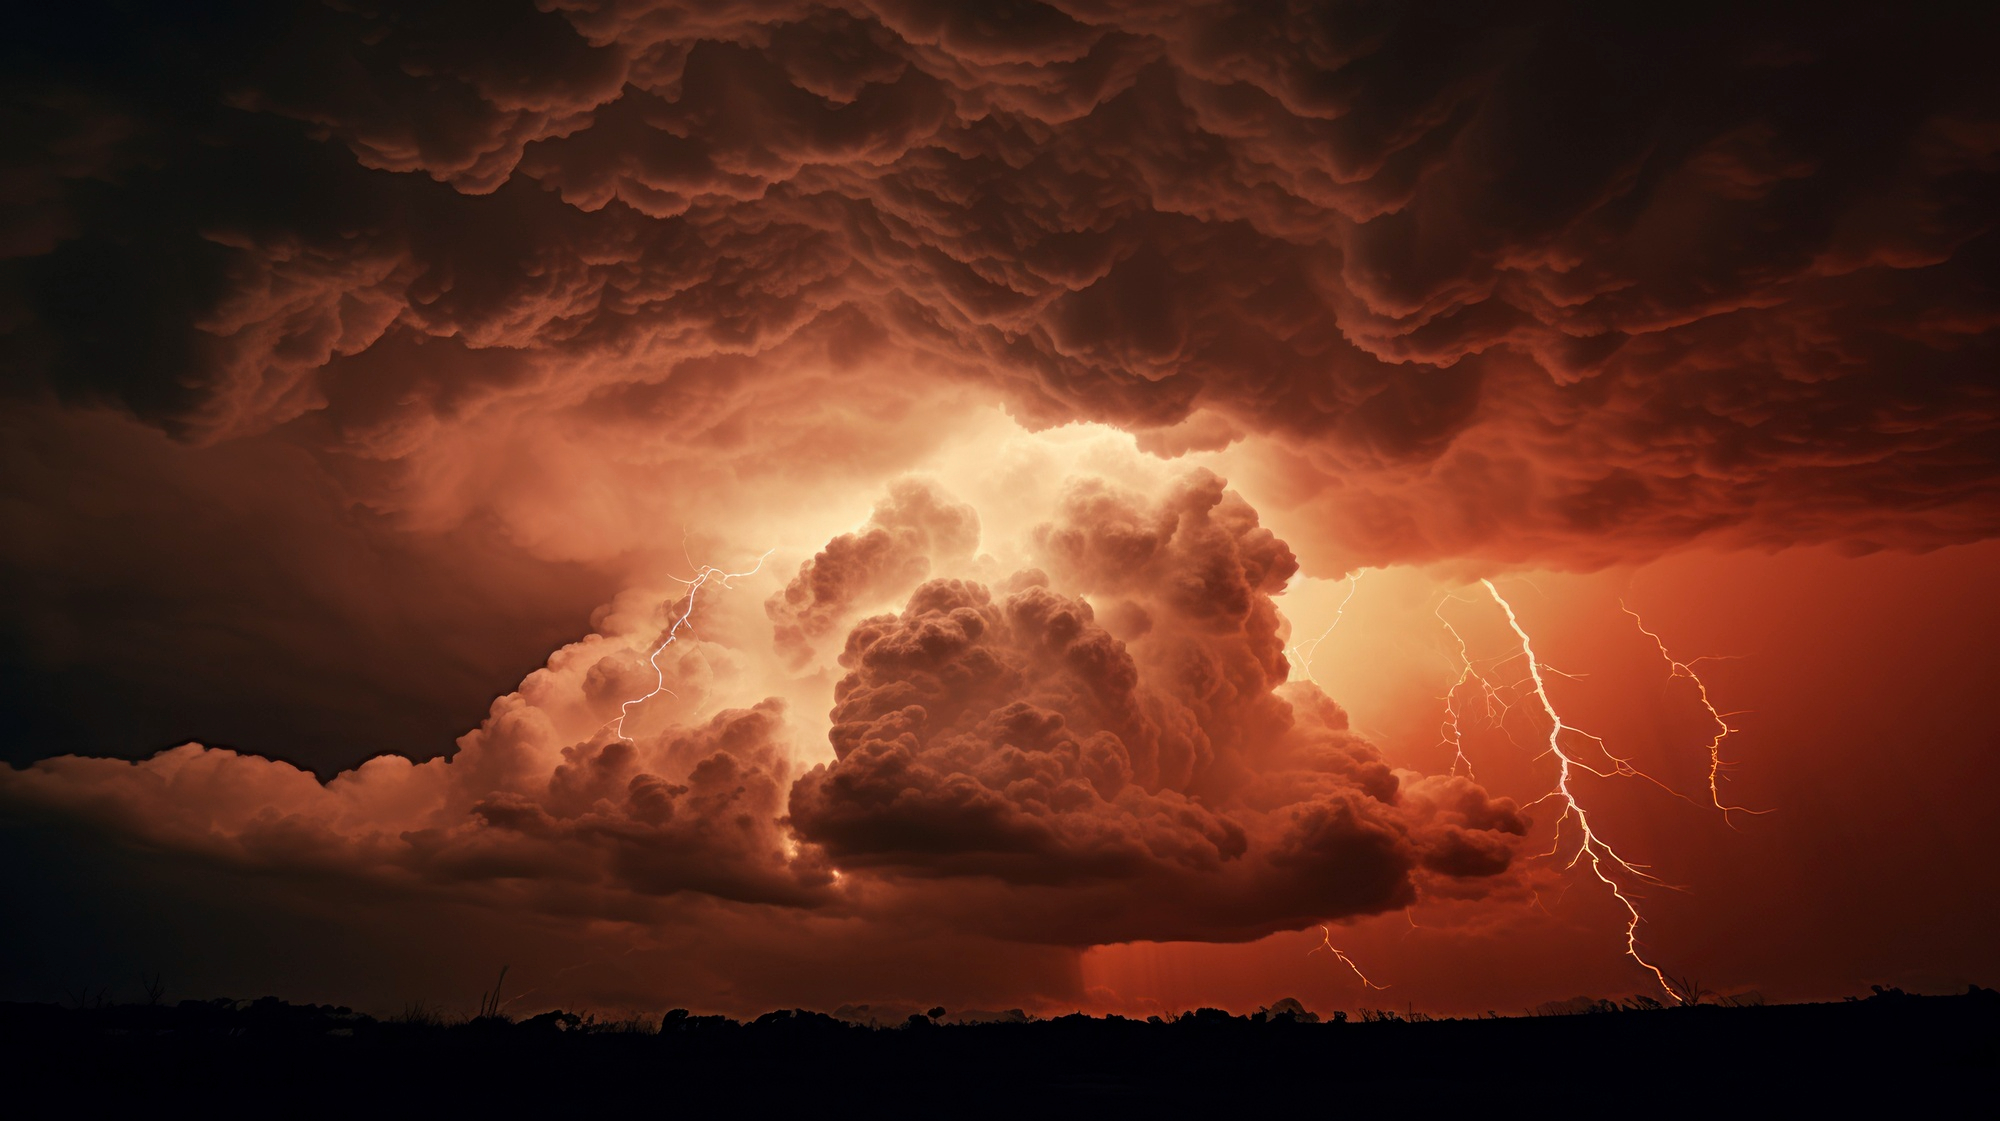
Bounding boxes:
[790,472,1526,943]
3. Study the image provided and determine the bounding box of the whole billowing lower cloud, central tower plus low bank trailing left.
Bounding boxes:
[0,472,1528,945]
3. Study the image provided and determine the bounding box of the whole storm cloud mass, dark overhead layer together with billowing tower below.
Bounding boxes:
[0,0,2000,1012]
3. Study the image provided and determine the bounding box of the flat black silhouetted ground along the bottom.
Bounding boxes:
[0,989,2000,1117]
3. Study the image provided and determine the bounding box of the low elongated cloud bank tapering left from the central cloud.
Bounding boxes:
[6,695,828,917]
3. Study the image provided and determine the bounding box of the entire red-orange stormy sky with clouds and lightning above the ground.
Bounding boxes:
[0,0,2000,1013]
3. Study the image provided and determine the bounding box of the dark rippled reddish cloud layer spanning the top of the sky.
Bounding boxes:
[4,0,2000,569]
